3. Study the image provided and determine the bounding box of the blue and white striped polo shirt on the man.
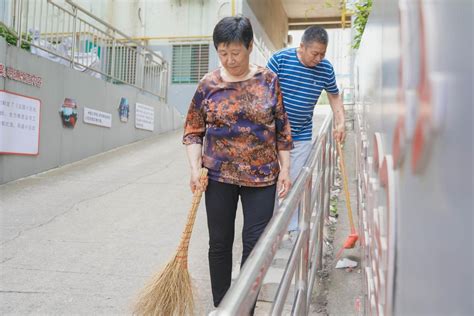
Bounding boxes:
[267,48,339,141]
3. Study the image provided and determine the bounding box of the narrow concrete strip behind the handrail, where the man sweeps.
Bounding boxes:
[256,106,364,316]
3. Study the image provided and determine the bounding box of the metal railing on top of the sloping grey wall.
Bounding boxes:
[12,0,169,101]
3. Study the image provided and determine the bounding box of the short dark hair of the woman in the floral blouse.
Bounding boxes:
[212,16,253,49]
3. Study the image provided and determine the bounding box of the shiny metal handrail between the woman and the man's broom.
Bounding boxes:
[213,115,336,316]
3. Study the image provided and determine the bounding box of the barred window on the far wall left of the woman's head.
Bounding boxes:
[171,44,209,83]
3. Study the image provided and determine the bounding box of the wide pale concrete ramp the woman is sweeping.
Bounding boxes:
[0,131,224,315]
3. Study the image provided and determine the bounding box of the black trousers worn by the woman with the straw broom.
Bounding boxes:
[206,180,276,307]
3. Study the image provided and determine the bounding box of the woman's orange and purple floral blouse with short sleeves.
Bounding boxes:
[183,67,293,187]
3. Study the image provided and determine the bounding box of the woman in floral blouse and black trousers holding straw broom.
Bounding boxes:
[183,17,293,307]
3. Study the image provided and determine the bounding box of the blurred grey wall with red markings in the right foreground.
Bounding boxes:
[355,0,474,315]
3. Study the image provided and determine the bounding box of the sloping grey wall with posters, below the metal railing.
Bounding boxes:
[0,39,182,183]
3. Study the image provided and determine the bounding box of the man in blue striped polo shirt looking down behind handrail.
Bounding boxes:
[267,26,344,235]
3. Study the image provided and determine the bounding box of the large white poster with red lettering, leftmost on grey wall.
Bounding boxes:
[0,90,41,155]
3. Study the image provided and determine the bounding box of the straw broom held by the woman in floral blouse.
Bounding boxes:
[134,168,207,316]
